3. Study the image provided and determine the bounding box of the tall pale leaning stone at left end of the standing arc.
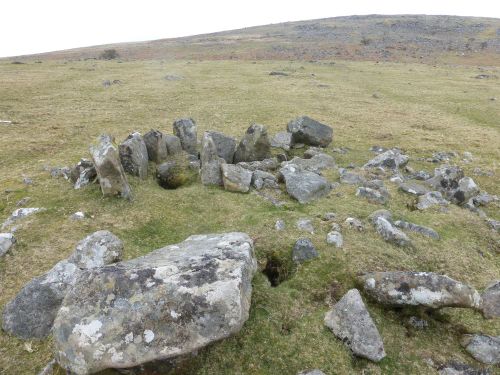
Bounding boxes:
[90,135,132,199]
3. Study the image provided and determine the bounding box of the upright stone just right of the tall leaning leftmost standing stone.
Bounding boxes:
[120,132,148,179]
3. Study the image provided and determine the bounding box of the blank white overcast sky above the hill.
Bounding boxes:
[0,0,500,57]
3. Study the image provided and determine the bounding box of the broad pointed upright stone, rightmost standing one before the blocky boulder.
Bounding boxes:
[234,124,271,163]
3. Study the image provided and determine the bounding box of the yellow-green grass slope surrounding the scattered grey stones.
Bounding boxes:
[0,61,500,374]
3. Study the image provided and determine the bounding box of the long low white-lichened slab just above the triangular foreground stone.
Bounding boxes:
[360,271,481,309]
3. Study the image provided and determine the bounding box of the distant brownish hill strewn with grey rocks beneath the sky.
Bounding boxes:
[7,15,500,65]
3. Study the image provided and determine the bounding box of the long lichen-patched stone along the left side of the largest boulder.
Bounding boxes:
[2,231,123,339]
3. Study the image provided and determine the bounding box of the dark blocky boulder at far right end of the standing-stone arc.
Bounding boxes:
[287,116,333,147]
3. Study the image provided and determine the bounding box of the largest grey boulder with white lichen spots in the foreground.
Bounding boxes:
[53,233,257,374]
